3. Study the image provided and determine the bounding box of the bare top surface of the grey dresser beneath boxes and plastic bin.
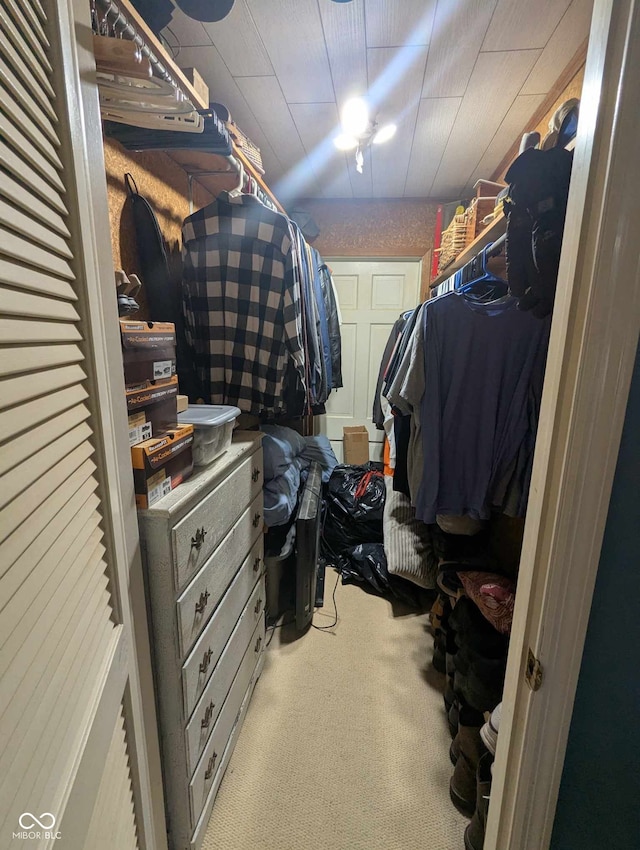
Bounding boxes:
[138,431,262,520]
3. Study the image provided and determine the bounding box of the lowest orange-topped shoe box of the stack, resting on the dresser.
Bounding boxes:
[131,425,193,509]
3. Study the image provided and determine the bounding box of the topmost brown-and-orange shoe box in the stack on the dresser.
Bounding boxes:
[120,319,176,388]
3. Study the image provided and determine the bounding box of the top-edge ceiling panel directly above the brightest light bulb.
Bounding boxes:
[320,0,367,107]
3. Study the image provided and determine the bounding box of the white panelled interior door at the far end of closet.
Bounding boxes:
[319,260,421,461]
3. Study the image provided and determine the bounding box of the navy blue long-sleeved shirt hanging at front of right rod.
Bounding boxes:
[416,293,550,523]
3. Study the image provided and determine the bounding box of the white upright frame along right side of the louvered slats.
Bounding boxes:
[52,0,167,850]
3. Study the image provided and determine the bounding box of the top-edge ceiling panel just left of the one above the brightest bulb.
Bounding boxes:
[248,0,335,103]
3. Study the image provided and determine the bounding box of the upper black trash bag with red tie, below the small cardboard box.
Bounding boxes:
[322,463,386,566]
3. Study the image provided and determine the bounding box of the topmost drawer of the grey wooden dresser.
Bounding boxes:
[171,452,263,590]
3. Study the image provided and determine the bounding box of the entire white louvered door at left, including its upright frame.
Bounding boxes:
[0,0,166,850]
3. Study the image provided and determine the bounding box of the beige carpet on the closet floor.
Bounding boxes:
[204,571,467,850]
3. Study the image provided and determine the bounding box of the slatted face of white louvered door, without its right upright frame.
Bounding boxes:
[0,0,155,850]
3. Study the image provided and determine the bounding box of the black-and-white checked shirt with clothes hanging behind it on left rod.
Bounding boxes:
[183,192,342,420]
